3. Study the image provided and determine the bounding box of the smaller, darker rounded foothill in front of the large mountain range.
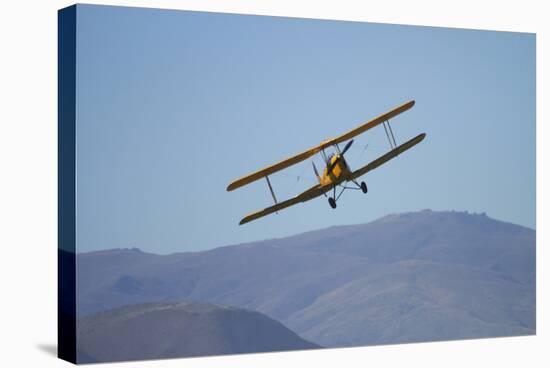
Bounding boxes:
[77,303,319,363]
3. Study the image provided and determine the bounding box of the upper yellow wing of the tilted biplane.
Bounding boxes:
[227,101,414,191]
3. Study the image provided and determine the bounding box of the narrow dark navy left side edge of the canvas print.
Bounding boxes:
[57,5,76,363]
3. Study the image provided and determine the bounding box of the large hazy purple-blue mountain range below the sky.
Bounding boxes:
[77,210,535,346]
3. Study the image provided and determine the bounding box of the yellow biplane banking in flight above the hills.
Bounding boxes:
[227,100,426,225]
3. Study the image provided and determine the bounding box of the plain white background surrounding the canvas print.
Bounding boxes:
[0,0,550,367]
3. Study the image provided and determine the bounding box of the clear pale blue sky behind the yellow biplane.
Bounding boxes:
[76,5,535,253]
